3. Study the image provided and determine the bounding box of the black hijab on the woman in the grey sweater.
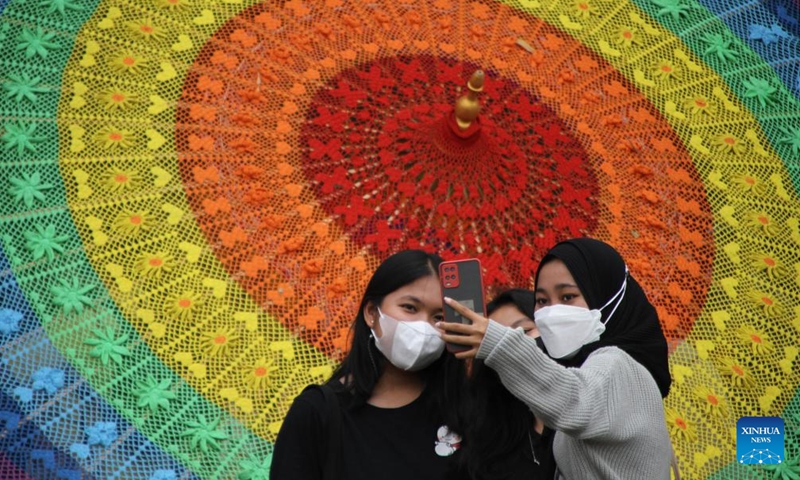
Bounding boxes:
[536,238,672,397]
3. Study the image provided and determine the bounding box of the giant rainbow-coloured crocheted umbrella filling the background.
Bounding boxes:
[0,0,800,480]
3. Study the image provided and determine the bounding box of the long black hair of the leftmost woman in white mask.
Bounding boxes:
[328,250,466,429]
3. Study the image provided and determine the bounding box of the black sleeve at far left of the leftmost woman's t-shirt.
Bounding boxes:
[269,388,328,480]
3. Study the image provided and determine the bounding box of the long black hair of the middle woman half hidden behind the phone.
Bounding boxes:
[461,289,536,479]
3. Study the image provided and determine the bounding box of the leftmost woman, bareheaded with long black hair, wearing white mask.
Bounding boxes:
[270,250,465,480]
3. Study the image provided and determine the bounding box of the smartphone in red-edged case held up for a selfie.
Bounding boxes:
[439,258,486,352]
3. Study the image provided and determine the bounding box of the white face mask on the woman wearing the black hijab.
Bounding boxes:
[533,267,628,358]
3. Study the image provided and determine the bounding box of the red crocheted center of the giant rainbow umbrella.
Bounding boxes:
[300,56,598,276]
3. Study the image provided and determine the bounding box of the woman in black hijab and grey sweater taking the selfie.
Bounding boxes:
[439,238,672,480]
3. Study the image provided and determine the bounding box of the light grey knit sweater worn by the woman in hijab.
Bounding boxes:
[478,320,672,480]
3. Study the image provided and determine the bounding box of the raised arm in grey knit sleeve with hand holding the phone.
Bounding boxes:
[438,300,663,438]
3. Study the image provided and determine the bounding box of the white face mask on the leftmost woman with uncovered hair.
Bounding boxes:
[371,308,444,372]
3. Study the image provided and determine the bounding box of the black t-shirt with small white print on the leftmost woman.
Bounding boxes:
[270,389,460,480]
